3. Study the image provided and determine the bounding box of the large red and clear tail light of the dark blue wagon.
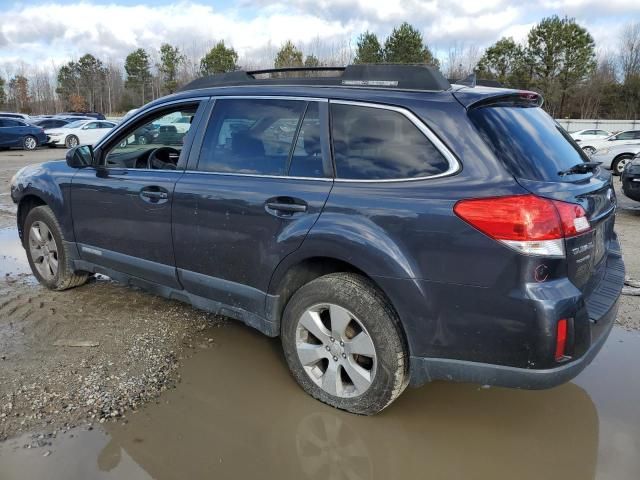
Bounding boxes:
[453,195,591,257]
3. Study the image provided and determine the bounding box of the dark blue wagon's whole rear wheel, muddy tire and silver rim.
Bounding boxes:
[281,273,409,415]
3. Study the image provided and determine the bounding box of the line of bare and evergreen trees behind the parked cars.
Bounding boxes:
[0,16,640,119]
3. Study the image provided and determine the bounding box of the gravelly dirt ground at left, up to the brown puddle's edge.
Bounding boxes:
[0,149,221,441]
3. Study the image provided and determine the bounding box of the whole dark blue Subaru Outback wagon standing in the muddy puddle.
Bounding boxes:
[11,65,624,414]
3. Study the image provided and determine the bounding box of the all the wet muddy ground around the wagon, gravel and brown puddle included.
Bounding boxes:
[0,150,640,480]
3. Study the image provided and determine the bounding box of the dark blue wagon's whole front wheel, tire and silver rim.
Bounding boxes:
[22,206,89,290]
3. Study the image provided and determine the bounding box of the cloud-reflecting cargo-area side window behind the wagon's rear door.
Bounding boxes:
[331,103,449,180]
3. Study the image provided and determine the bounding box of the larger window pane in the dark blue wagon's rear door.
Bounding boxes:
[198,99,306,175]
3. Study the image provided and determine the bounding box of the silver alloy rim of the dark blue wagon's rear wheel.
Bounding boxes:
[296,304,377,398]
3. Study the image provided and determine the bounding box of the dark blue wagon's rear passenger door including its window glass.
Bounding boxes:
[173,98,333,315]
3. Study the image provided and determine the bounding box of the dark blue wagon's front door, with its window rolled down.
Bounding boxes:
[71,102,205,288]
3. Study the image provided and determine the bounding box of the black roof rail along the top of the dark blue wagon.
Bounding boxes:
[179,64,451,91]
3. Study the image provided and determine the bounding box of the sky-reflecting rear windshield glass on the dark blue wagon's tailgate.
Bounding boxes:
[469,106,592,182]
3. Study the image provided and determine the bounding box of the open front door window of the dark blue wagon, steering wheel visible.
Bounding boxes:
[105,104,198,170]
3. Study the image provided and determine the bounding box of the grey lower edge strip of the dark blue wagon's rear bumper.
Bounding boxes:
[411,301,618,390]
